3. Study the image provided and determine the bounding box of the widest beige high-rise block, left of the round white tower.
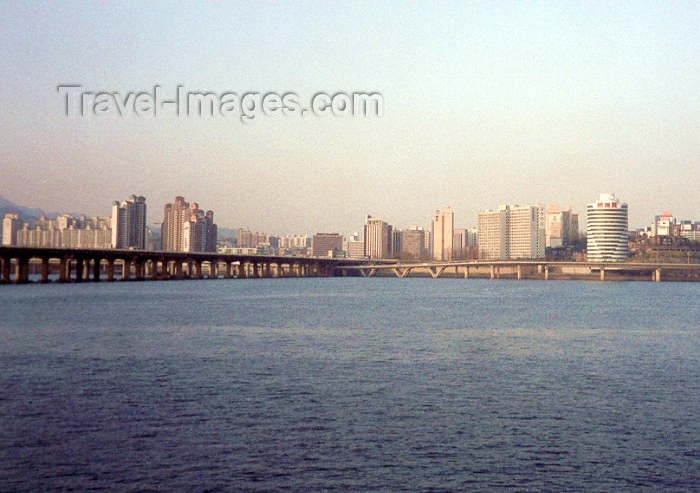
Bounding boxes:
[478,205,545,260]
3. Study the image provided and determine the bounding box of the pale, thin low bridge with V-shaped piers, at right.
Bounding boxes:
[336,260,700,281]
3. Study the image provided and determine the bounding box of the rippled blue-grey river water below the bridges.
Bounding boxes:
[0,278,700,491]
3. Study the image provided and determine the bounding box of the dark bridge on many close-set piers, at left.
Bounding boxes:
[0,247,388,284]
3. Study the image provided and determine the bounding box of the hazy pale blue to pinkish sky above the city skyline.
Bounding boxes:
[0,0,700,234]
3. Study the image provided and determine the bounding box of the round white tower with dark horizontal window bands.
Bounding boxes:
[586,193,629,262]
